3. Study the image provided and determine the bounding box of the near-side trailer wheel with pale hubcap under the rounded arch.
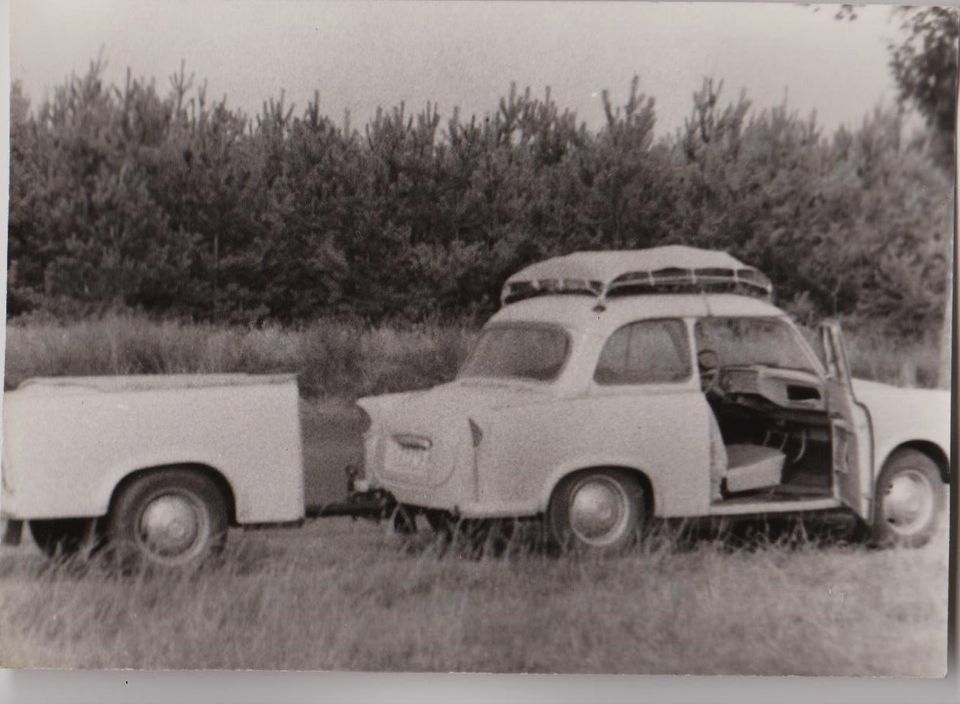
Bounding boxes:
[107,468,228,568]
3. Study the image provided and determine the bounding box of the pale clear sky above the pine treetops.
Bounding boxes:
[10,0,899,135]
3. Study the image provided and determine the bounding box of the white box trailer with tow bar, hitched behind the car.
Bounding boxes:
[0,374,385,566]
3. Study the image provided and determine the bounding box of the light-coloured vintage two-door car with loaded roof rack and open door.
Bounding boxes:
[356,246,950,552]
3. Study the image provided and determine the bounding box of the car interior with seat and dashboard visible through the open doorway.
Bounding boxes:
[696,318,833,504]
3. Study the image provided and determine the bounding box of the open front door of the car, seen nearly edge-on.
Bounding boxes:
[820,320,873,521]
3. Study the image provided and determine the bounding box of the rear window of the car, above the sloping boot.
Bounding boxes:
[458,325,570,381]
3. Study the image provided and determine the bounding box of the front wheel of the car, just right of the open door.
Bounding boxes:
[871,449,944,548]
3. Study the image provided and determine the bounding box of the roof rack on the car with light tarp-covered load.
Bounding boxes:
[500,245,773,305]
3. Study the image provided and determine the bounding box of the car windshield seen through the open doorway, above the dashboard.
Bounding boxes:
[696,318,818,373]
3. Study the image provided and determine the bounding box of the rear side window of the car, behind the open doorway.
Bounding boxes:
[593,320,691,386]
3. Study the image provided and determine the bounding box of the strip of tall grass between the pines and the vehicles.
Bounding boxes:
[5,315,938,398]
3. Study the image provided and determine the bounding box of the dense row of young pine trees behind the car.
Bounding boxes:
[8,57,953,333]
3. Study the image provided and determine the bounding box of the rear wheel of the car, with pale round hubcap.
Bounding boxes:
[546,468,647,554]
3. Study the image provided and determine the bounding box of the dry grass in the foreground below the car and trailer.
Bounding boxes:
[0,519,947,676]
